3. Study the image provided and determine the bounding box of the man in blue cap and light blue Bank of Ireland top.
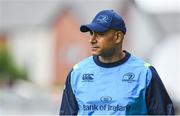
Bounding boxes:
[60,10,174,115]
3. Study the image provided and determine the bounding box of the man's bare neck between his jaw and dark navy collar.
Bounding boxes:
[98,51,125,63]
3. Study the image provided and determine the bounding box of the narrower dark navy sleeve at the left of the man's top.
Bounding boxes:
[59,70,79,115]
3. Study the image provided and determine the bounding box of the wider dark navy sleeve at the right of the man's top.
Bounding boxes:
[146,66,174,115]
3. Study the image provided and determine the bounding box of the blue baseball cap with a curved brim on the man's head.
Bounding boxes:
[80,10,126,34]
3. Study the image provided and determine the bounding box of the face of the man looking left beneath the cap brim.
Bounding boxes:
[89,30,117,57]
